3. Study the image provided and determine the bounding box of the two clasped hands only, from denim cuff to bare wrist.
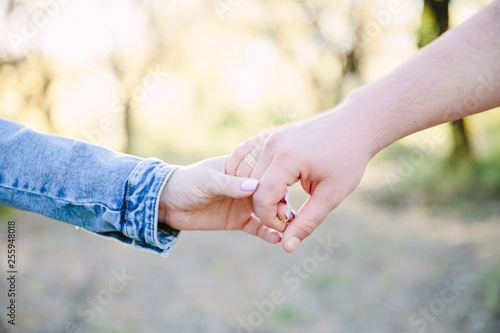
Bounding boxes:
[158,104,372,252]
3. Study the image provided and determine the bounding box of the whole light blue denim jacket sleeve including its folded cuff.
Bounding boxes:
[0,119,179,256]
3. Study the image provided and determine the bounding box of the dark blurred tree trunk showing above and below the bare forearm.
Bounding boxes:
[420,0,472,161]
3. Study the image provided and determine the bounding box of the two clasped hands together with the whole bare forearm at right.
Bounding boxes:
[158,1,500,252]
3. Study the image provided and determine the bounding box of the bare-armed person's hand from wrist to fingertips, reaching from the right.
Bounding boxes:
[225,103,372,252]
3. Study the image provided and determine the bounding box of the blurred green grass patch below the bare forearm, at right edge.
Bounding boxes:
[367,148,500,221]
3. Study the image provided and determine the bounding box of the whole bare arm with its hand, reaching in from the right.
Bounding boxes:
[225,0,500,252]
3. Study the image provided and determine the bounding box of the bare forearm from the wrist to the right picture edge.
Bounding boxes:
[346,0,500,154]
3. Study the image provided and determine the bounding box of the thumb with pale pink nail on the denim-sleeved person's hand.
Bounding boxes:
[207,172,259,199]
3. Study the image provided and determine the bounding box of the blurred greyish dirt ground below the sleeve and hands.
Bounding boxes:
[0,189,500,333]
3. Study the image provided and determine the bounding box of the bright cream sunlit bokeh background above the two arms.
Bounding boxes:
[0,0,498,161]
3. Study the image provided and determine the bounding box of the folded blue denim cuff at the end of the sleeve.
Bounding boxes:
[123,158,179,256]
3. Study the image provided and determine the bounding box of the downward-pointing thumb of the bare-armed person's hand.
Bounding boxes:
[282,188,338,252]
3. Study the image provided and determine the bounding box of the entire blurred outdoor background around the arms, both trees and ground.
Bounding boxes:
[0,0,500,333]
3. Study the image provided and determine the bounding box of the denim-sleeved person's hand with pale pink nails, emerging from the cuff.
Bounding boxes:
[158,157,283,244]
